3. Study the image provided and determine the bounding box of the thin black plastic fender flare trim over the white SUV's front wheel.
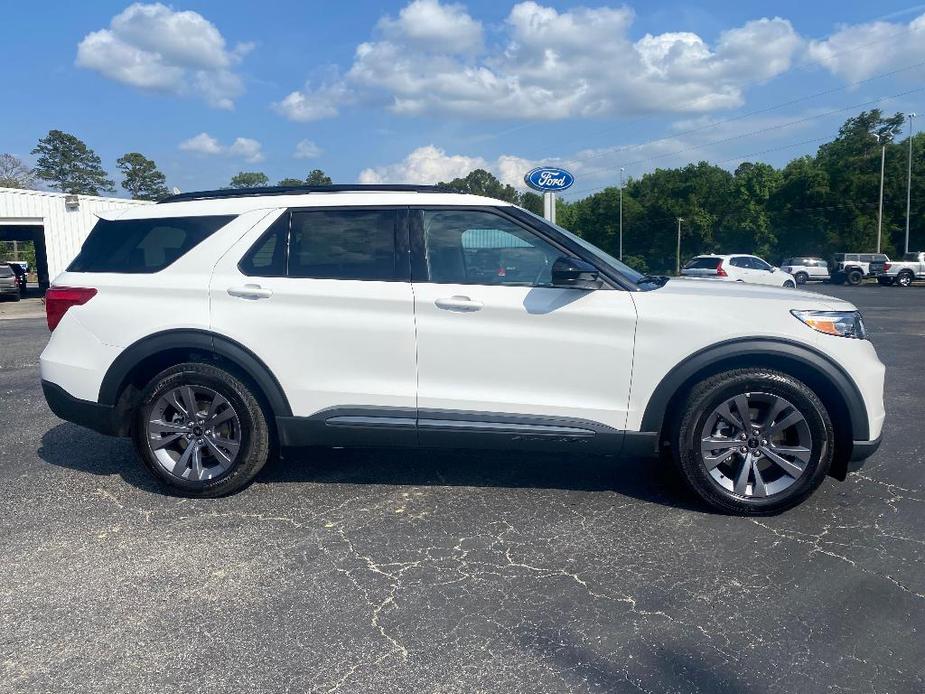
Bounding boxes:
[641,338,870,441]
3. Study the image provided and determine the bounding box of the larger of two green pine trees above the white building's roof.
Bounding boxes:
[32,130,115,195]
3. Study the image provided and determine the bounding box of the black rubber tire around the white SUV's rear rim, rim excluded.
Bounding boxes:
[132,362,271,497]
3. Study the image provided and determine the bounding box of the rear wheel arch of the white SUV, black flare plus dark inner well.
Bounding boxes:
[98,329,292,436]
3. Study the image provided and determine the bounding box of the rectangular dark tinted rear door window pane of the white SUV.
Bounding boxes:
[288,210,398,281]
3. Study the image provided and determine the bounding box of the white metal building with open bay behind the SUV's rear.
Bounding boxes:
[0,188,151,288]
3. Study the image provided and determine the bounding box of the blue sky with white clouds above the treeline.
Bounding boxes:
[0,0,925,194]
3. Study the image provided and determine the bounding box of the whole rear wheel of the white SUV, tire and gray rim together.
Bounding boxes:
[133,363,270,497]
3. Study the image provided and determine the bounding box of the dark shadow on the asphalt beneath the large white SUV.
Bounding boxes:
[37,423,705,511]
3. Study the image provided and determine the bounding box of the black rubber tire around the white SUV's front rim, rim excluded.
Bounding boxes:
[672,369,834,516]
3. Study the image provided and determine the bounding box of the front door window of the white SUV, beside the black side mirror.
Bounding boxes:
[423,210,565,286]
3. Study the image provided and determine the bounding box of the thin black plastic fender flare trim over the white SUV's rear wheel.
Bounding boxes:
[98,329,292,417]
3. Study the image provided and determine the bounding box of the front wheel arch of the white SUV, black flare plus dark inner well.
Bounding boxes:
[641,338,870,479]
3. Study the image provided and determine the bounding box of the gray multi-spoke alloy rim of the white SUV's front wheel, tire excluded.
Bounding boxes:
[700,392,813,499]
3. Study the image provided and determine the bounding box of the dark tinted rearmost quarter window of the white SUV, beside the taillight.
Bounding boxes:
[67,215,234,274]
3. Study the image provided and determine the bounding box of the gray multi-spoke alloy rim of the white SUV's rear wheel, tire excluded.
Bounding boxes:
[145,385,241,482]
